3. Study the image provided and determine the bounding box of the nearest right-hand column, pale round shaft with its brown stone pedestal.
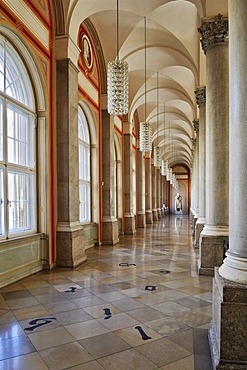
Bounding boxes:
[209,0,247,370]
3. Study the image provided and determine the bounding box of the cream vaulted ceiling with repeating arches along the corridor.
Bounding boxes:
[55,0,227,167]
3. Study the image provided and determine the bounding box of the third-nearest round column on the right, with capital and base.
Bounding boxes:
[195,86,206,248]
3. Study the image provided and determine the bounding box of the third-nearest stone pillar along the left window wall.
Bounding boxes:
[124,122,136,234]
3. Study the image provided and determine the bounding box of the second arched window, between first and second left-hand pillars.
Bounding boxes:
[78,106,91,222]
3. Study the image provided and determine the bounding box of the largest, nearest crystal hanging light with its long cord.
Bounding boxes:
[107,0,129,115]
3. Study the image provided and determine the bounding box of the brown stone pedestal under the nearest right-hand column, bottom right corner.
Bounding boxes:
[209,268,247,370]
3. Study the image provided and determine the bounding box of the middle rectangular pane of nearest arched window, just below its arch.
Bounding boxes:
[7,104,34,167]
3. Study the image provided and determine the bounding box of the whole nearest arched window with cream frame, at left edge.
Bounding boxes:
[0,35,37,238]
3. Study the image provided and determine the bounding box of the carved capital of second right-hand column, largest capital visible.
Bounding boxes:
[198,14,229,54]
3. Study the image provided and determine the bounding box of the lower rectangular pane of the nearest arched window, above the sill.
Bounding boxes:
[8,172,35,234]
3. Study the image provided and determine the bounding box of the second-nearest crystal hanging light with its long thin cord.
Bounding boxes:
[140,17,152,152]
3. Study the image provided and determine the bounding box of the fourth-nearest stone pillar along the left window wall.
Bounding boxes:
[136,145,146,228]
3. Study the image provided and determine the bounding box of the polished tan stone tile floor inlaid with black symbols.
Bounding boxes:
[0,216,212,370]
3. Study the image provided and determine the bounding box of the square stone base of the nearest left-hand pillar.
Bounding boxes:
[56,223,87,268]
